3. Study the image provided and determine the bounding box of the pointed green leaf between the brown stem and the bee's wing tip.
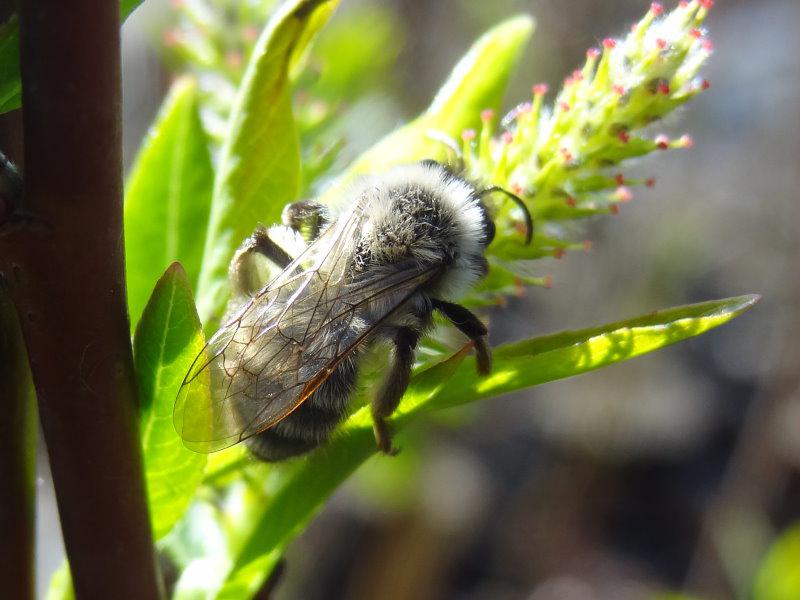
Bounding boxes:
[133,263,206,539]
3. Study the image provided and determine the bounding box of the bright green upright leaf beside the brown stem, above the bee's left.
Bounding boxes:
[125,78,214,326]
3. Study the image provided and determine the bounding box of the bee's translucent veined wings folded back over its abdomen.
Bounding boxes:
[173,199,434,452]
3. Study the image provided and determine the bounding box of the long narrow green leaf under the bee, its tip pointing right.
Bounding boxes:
[212,296,758,598]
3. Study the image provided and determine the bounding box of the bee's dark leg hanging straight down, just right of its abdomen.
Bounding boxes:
[372,327,419,455]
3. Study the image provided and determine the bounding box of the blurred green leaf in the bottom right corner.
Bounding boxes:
[753,524,800,600]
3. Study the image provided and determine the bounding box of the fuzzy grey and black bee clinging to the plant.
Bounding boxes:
[173,160,532,462]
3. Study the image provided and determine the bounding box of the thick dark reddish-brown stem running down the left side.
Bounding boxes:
[0,0,159,600]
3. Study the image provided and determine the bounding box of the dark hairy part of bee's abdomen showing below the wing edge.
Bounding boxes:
[246,357,356,462]
